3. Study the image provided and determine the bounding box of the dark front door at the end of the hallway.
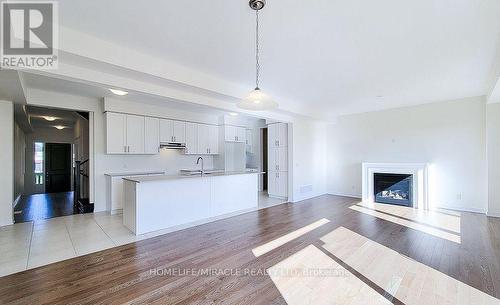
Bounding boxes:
[45,143,71,193]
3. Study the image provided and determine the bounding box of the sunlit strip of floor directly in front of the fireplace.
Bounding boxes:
[349,204,461,244]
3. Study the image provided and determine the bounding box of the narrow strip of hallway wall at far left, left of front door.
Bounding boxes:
[14,123,26,200]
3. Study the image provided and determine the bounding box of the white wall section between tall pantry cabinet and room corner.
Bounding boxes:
[288,121,327,202]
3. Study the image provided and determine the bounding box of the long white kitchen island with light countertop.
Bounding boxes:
[123,171,261,235]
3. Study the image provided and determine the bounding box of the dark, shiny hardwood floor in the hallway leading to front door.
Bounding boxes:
[14,192,73,223]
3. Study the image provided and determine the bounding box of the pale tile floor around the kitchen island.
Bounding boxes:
[0,193,284,276]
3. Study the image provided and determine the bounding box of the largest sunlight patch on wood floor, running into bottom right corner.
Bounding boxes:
[321,227,500,305]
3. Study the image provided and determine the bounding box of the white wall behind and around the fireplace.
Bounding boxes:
[328,98,488,212]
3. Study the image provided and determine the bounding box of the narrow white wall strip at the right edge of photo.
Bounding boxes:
[486,103,500,217]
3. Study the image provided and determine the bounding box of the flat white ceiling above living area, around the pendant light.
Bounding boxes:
[59,0,500,115]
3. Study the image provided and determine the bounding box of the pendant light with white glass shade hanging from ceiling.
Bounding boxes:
[238,0,278,111]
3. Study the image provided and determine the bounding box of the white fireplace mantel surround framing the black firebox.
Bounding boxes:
[362,163,429,210]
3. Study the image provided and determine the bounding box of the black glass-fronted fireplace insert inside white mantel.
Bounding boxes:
[373,173,413,207]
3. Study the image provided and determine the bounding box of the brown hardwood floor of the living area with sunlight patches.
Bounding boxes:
[0,196,500,305]
